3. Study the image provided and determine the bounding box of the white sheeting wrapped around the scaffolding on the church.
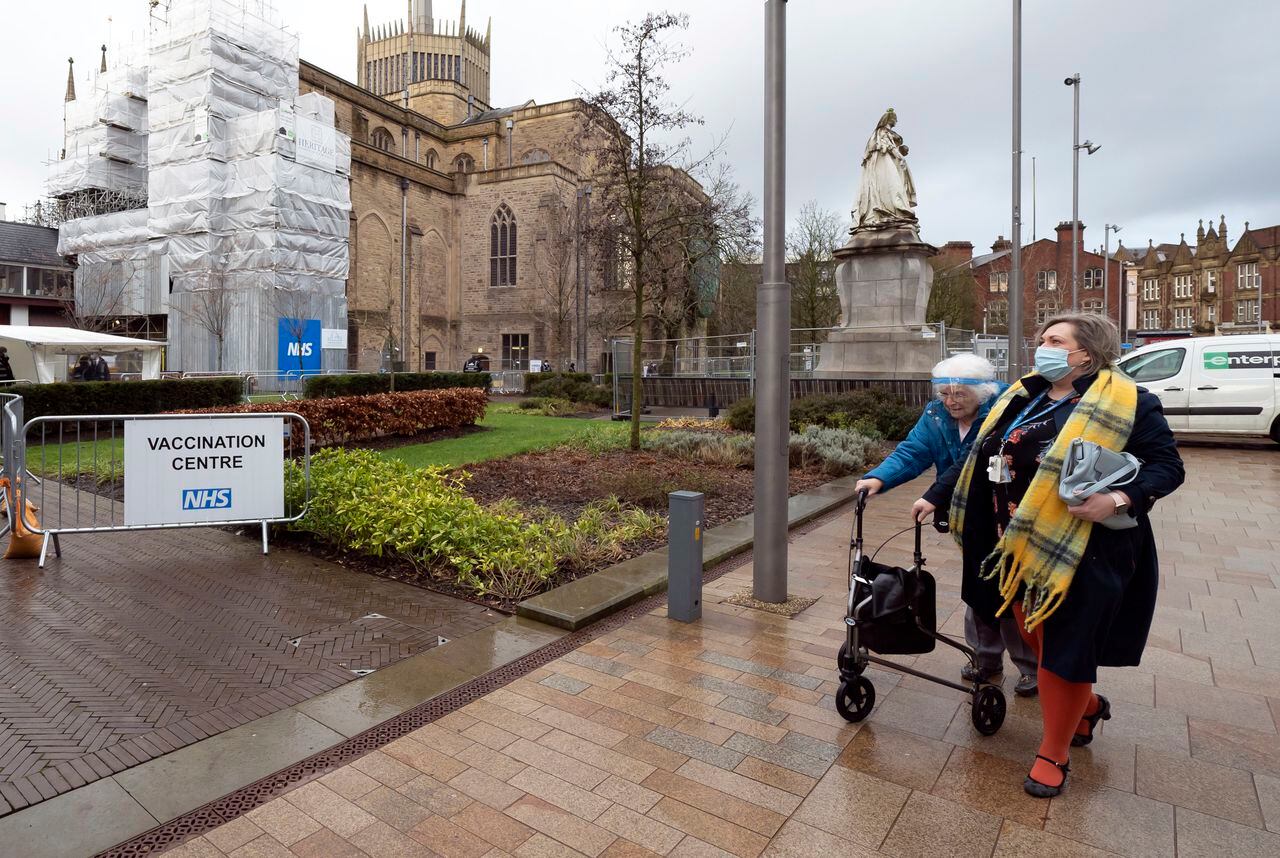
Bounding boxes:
[53,0,351,371]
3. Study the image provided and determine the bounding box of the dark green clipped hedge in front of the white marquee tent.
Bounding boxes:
[15,378,244,420]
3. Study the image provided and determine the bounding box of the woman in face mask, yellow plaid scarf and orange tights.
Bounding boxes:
[913,314,1184,798]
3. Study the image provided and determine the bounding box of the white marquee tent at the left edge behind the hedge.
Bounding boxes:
[0,325,165,384]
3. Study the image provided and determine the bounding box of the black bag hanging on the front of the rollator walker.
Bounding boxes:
[854,557,937,656]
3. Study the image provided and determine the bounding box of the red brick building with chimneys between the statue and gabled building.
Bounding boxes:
[934,222,1124,338]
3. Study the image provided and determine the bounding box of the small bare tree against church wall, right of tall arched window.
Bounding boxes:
[532,197,589,369]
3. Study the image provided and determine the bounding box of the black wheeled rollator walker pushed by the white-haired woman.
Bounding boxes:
[836,490,1005,736]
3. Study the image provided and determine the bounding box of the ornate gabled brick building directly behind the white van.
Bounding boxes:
[1130,216,1280,336]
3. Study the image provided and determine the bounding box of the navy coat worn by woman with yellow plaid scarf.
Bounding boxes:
[924,375,1185,683]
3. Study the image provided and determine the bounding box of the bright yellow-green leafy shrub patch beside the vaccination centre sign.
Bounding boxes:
[285,449,664,601]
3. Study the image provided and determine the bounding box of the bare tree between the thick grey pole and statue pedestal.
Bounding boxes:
[787,200,845,343]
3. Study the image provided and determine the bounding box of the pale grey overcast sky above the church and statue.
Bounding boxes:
[0,0,1280,252]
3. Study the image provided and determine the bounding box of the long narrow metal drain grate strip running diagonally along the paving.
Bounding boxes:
[93,507,846,858]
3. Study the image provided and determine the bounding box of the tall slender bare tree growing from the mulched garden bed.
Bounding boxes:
[580,13,750,449]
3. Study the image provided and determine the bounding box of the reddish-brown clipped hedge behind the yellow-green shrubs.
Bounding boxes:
[182,388,489,447]
